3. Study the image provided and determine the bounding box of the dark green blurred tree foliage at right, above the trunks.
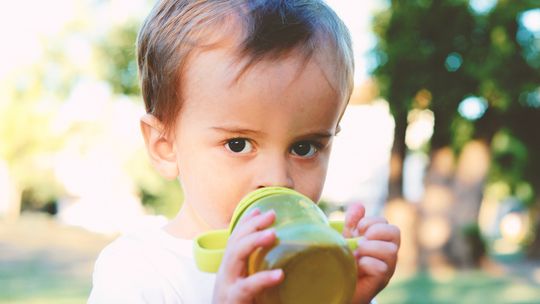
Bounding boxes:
[374,0,540,202]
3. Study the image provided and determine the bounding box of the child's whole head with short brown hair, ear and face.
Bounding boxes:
[138,0,353,232]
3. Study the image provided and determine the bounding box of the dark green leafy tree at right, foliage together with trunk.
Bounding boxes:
[374,0,540,265]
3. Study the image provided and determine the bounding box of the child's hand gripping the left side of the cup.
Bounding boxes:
[213,210,283,304]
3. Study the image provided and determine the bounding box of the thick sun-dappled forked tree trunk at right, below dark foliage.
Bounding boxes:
[419,141,490,268]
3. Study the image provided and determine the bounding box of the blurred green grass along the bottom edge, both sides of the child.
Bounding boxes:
[4,261,540,304]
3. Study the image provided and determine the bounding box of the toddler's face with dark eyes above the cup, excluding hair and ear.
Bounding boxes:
[174,48,345,229]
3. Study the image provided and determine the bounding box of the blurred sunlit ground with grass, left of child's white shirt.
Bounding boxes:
[0,215,111,304]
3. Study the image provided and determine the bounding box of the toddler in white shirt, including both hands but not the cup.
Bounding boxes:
[89,0,399,303]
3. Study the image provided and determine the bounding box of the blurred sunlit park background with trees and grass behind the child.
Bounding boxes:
[0,0,540,303]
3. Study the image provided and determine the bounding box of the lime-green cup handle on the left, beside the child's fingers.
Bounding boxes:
[193,229,229,273]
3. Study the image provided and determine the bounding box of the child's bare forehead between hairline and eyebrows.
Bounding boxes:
[180,43,345,131]
